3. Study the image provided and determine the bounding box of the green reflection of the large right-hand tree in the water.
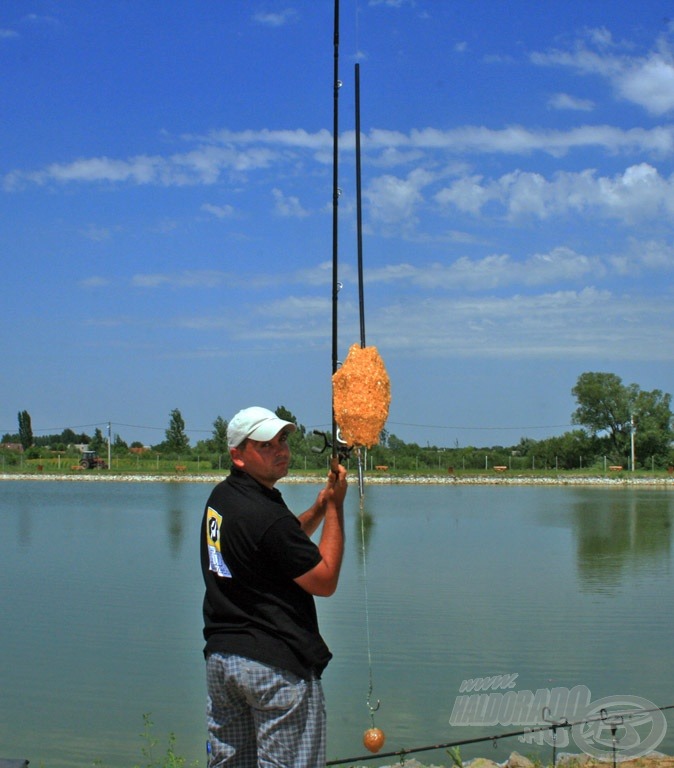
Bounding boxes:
[572,492,672,592]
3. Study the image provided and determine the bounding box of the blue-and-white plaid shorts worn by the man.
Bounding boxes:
[206,653,326,768]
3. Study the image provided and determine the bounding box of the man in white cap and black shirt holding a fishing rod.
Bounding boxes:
[201,407,347,768]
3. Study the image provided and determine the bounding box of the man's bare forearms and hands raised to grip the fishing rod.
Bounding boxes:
[295,465,347,597]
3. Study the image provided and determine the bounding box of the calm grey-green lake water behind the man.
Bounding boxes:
[0,482,674,768]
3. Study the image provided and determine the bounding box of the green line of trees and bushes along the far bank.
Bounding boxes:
[2,372,674,471]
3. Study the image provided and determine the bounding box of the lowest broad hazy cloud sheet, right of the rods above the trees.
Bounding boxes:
[369,288,674,362]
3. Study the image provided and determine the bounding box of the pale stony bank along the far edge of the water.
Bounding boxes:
[0,471,674,489]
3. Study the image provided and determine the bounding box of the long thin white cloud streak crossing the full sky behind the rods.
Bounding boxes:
[7,125,674,194]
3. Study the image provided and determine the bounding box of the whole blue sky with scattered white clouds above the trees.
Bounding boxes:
[0,0,674,446]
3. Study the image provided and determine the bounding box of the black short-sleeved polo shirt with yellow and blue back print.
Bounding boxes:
[201,468,332,677]
